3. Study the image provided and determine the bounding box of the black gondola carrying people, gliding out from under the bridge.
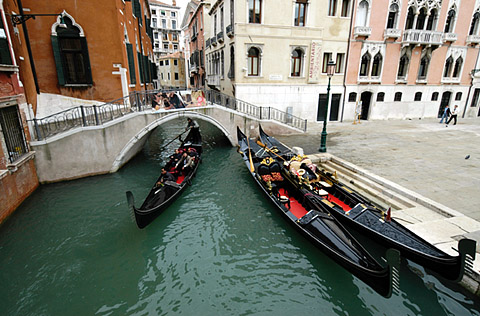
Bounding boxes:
[126,128,202,228]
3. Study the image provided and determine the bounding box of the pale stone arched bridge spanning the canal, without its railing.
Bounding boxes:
[30,104,303,183]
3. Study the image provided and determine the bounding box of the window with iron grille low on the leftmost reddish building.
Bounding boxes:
[0,105,28,163]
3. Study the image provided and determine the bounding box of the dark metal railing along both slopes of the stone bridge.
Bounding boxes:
[28,87,307,140]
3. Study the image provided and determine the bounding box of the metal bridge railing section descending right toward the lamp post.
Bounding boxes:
[205,90,307,131]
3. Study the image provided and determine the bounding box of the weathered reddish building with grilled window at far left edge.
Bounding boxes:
[0,0,38,223]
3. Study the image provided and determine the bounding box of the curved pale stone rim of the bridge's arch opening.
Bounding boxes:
[110,111,236,172]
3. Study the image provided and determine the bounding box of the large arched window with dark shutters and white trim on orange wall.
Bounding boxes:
[51,15,93,86]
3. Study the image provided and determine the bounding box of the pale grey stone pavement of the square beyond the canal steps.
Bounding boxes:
[276,118,480,221]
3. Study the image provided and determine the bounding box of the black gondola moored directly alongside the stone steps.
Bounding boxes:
[260,127,476,282]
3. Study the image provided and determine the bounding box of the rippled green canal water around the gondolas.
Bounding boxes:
[0,121,480,316]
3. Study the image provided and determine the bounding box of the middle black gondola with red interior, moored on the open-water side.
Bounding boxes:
[237,127,400,297]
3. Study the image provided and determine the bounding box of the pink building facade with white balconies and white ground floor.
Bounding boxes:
[343,0,480,120]
